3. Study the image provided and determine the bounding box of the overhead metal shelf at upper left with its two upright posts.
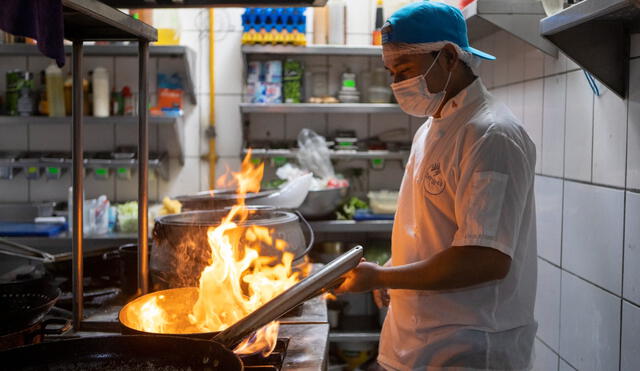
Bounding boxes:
[33,0,158,331]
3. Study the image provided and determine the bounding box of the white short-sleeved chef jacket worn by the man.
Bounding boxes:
[378,78,537,370]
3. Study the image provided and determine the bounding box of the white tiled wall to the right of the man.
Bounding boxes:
[476,28,640,371]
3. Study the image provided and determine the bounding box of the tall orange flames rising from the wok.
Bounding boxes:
[131,152,301,356]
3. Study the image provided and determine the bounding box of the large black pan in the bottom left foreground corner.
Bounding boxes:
[0,335,243,371]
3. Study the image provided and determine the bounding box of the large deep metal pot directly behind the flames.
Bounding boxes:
[150,206,313,289]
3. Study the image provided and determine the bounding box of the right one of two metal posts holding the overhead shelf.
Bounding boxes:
[138,40,149,295]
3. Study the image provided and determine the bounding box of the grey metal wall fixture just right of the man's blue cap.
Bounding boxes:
[462,0,558,57]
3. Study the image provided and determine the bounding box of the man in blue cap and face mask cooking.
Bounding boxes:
[337,2,537,370]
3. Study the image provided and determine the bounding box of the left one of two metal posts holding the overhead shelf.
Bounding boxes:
[71,40,84,331]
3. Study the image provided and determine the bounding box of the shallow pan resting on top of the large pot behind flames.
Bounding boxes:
[176,189,276,211]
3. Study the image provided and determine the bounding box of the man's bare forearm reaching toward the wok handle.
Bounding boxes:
[374,246,511,290]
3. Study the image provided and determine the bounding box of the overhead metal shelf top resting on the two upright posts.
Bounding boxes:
[62,0,158,41]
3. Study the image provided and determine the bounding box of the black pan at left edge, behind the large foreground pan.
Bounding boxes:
[0,280,60,334]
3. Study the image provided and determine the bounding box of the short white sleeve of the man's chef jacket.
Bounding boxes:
[452,132,535,257]
